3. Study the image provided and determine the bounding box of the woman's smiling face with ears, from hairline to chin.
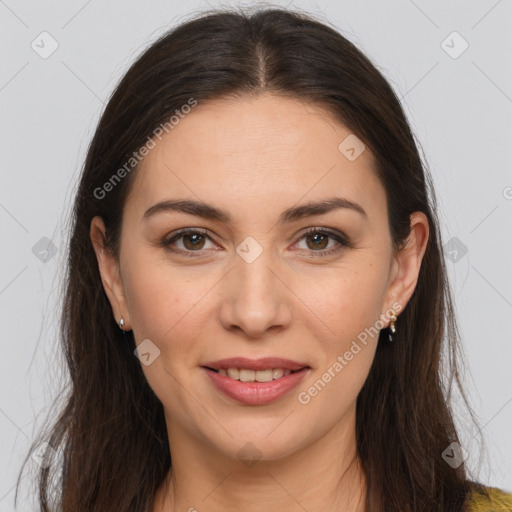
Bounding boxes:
[91,94,428,460]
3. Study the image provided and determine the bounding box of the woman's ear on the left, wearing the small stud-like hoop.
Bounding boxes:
[89,216,131,331]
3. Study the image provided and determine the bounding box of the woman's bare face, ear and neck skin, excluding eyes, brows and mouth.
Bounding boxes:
[90,93,428,512]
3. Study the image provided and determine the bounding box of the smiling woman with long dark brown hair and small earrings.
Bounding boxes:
[15,5,512,512]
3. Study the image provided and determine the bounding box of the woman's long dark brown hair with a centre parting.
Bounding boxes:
[16,9,488,512]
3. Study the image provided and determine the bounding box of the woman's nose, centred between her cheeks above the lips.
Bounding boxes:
[220,250,294,338]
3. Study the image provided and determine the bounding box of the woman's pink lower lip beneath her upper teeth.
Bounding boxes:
[203,367,309,405]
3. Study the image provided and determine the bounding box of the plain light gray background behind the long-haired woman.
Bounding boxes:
[0,0,512,512]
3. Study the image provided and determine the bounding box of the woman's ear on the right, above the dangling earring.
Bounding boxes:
[384,212,429,322]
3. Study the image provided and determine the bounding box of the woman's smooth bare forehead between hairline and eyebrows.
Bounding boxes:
[127,94,385,226]
